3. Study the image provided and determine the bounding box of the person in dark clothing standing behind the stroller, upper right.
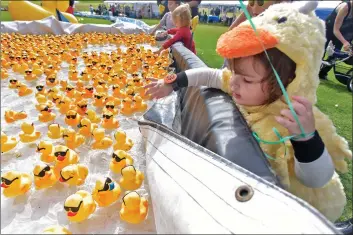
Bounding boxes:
[319,0,353,80]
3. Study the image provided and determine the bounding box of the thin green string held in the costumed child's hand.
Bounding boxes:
[239,0,315,161]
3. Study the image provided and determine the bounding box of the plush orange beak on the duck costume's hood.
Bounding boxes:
[216,25,278,59]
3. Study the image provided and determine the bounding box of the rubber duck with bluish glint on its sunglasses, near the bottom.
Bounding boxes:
[92,177,121,207]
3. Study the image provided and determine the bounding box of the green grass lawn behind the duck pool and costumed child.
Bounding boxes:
[0,9,352,220]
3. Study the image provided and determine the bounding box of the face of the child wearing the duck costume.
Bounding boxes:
[230,56,269,106]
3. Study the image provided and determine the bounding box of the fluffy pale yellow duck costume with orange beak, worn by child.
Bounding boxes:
[217,2,352,221]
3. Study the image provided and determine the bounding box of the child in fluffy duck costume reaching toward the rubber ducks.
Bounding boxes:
[146,2,352,221]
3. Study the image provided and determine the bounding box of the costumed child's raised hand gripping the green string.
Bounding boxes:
[275,96,315,141]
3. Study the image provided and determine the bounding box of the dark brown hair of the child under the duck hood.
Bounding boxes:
[228,48,297,104]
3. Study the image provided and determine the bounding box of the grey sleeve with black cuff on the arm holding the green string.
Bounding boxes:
[291,131,335,188]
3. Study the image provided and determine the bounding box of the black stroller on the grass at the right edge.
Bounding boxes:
[321,43,353,92]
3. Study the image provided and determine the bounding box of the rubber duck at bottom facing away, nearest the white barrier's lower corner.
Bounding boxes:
[120,191,148,224]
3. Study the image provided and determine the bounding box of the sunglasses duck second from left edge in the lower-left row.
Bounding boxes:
[33,162,58,190]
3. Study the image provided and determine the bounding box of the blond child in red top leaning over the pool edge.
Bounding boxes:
[155,4,196,54]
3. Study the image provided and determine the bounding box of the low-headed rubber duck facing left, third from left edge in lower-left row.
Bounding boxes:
[59,164,88,186]
